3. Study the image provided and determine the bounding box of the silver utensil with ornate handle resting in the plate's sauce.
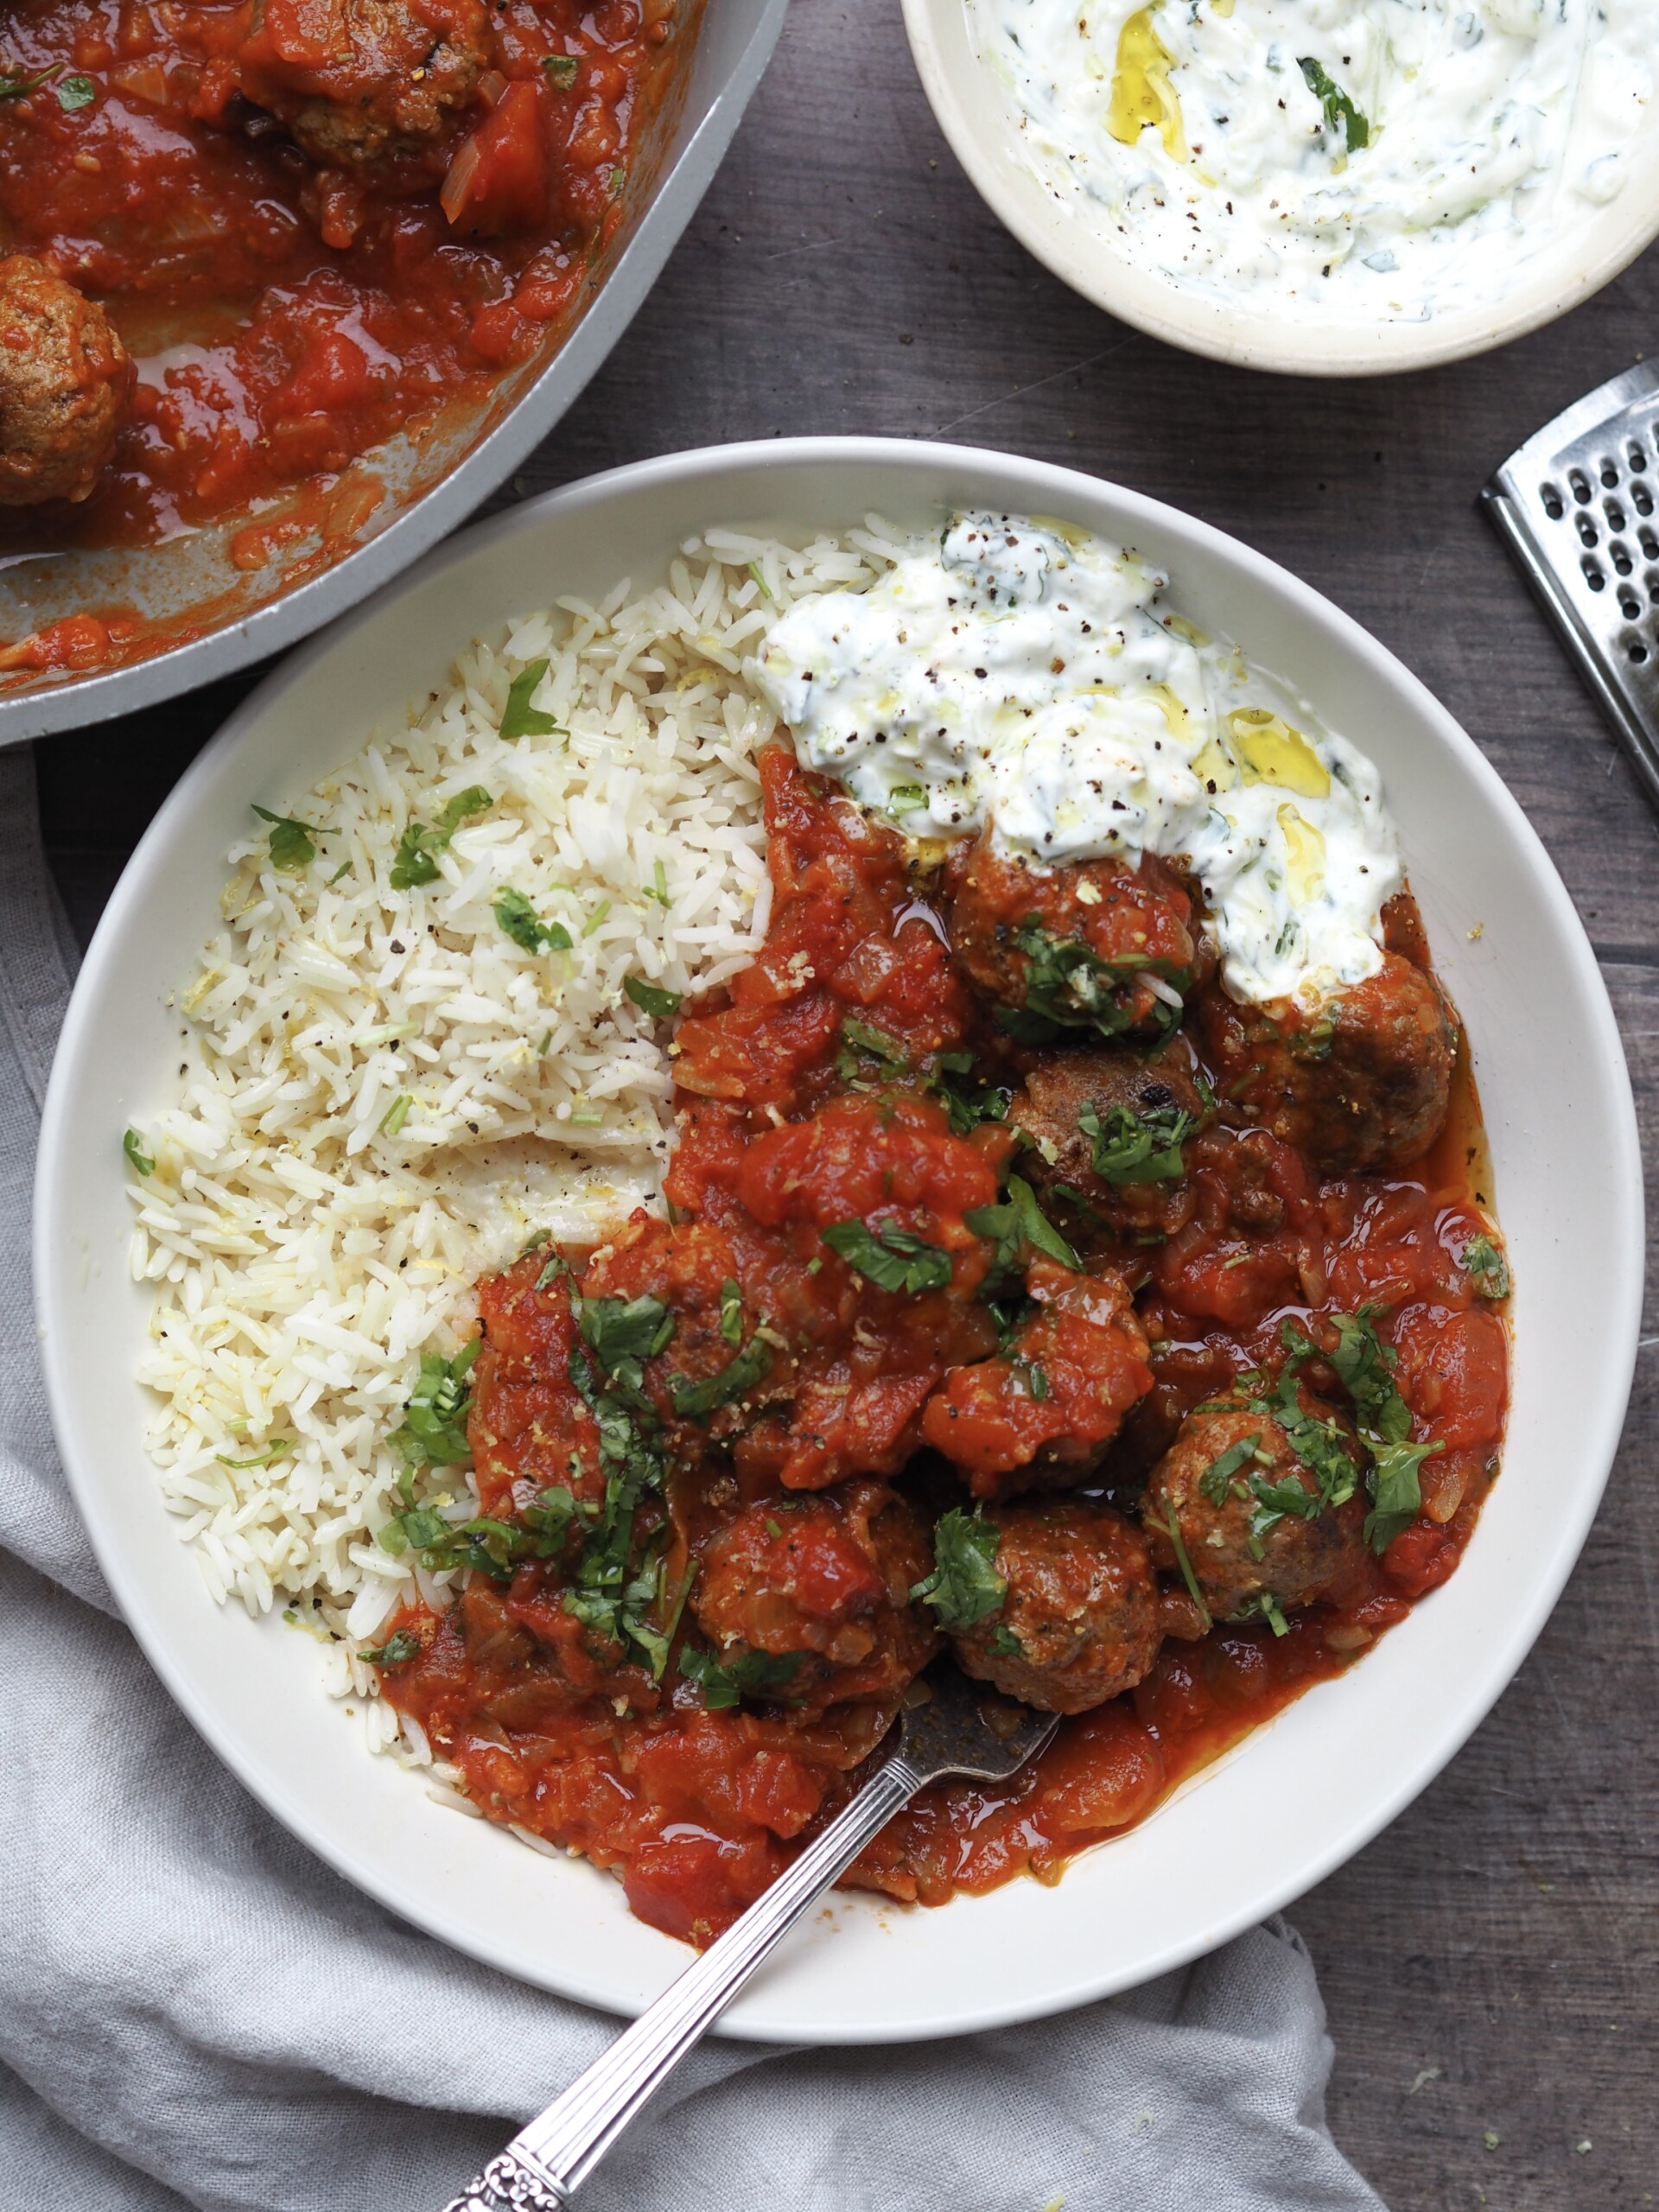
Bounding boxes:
[445,1666,1059,2212]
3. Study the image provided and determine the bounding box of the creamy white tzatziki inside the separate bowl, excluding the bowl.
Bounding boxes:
[973,0,1659,321]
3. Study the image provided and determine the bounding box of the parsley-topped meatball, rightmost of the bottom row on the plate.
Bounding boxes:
[1141,1394,1367,1621]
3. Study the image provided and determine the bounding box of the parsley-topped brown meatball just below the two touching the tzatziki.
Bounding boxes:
[1008,1038,1205,1230]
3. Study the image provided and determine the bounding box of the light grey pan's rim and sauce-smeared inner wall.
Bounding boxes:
[0,0,790,746]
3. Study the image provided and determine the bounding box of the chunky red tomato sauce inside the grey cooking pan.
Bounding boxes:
[0,0,688,553]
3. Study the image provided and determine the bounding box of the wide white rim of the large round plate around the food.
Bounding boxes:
[35,438,1643,2044]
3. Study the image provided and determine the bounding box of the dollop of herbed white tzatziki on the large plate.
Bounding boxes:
[746,513,1405,1004]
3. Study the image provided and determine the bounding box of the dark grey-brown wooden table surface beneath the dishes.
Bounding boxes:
[38,0,1659,2212]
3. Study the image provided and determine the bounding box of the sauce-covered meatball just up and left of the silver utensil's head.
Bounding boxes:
[692,1482,938,1712]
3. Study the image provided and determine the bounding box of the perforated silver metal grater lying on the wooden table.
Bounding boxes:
[1480,360,1659,807]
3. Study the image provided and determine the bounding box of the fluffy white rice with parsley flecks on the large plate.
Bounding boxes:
[130,518,900,1645]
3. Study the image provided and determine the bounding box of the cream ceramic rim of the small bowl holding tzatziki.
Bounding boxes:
[905,0,1659,376]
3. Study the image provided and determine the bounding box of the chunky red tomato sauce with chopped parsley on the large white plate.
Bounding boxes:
[380,746,1506,1944]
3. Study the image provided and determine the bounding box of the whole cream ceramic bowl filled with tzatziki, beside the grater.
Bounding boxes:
[905,0,1659,376]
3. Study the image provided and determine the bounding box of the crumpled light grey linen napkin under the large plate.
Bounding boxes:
[0,747,1380,2212]
